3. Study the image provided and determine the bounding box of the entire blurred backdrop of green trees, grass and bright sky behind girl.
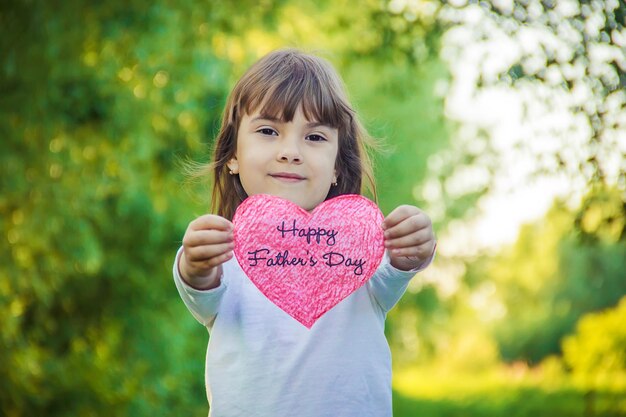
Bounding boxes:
[0,0,626,417]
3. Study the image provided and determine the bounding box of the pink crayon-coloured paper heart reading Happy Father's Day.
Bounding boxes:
[233,194,385,328]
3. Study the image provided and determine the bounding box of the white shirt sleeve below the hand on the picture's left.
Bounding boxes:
[173,248,227,327]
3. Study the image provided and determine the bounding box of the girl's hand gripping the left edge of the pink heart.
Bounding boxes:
[178,214,234,290]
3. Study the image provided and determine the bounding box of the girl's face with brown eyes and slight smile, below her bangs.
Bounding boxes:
[228,107,339,211]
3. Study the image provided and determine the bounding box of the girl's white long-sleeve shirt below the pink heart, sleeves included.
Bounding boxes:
[174,251,426,417]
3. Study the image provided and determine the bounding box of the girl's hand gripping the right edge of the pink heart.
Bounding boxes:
[382,205,435,271]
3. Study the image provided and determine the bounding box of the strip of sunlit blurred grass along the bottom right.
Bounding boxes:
[394,368,626,417]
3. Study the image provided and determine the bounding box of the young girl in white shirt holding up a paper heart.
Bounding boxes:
[174,50,435,417]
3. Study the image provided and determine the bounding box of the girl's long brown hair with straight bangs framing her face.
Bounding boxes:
[197,49,376,219]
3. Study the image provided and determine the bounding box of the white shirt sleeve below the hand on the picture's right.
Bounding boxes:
[367,247,435,313]
